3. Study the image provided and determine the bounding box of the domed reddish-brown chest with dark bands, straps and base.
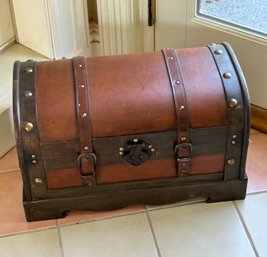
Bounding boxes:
[14,43,250,221]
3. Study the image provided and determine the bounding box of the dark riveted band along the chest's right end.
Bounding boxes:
[208,44,245,180]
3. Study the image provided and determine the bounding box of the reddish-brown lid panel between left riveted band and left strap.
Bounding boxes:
[36,60,78,141]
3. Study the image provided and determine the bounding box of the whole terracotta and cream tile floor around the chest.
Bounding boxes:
[0,130,267,257]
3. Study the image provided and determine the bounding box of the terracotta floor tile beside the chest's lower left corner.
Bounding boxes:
[0,171,56,236]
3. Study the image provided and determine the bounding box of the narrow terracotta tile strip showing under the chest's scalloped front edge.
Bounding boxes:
[57,205,145,225]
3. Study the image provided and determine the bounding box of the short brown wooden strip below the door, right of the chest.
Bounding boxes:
[251,104,267,133]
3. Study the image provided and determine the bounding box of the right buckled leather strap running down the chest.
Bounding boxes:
[162,48,192,176]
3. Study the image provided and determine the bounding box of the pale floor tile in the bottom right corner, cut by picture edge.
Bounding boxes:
[236,193,267,257]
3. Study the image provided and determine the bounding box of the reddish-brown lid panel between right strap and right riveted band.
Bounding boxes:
[177,47,227,128]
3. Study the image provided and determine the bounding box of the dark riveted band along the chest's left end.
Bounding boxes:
[14,61,47,199]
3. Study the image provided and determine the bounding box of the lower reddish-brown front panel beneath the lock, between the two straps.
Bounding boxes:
[96,159,176,184]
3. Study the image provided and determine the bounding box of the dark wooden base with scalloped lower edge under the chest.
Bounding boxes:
[24,178,247,221]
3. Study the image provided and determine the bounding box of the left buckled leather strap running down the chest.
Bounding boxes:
[72,57,96,186]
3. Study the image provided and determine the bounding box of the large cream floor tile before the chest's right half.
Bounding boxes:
[149,202,255,257]
